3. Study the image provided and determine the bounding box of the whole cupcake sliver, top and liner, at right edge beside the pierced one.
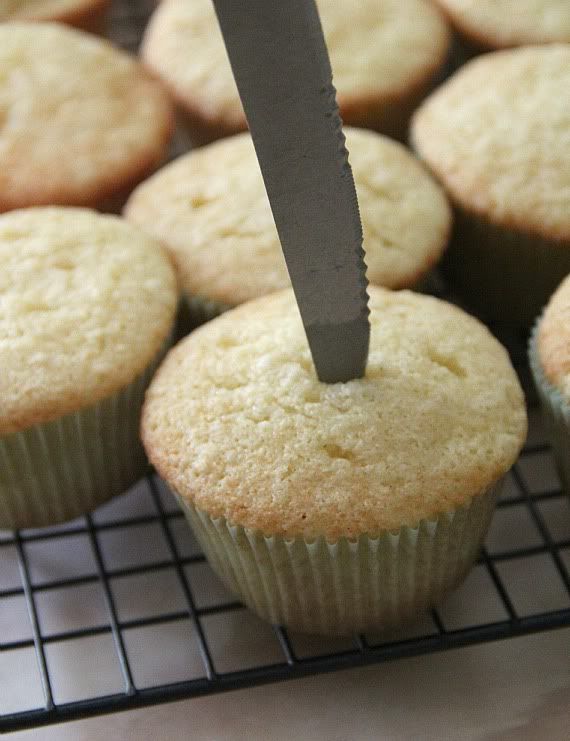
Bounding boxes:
[529,276,570,493]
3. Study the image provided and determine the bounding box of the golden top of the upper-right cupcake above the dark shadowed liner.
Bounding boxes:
[412,44,570,241]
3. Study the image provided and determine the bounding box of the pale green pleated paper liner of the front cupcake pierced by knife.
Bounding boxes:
[175,482,501,635]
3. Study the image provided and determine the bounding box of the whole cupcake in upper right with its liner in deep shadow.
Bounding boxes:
[412,44,570,326]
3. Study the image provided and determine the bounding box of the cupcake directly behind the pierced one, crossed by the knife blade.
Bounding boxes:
[125,129,451,325]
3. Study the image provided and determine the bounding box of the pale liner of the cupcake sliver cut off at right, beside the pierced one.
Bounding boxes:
[528,322,570,493]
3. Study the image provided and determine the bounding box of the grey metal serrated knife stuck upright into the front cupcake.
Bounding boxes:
[209,0,370,383]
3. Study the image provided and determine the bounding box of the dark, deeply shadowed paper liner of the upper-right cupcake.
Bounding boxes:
[442,208,570,327]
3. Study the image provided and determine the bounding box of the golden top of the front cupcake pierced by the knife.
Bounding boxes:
[142,287,526,540]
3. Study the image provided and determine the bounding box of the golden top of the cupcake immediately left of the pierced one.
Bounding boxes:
[0,208,177,435]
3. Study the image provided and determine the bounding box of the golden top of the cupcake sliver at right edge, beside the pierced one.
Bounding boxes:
[537,276,570,404]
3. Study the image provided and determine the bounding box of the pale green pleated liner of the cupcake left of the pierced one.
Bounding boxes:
[0,342,170,529]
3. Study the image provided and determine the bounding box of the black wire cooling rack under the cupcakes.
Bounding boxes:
[0,0,570,731]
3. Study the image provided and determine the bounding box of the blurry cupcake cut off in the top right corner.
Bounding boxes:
[433,0,570,53]
